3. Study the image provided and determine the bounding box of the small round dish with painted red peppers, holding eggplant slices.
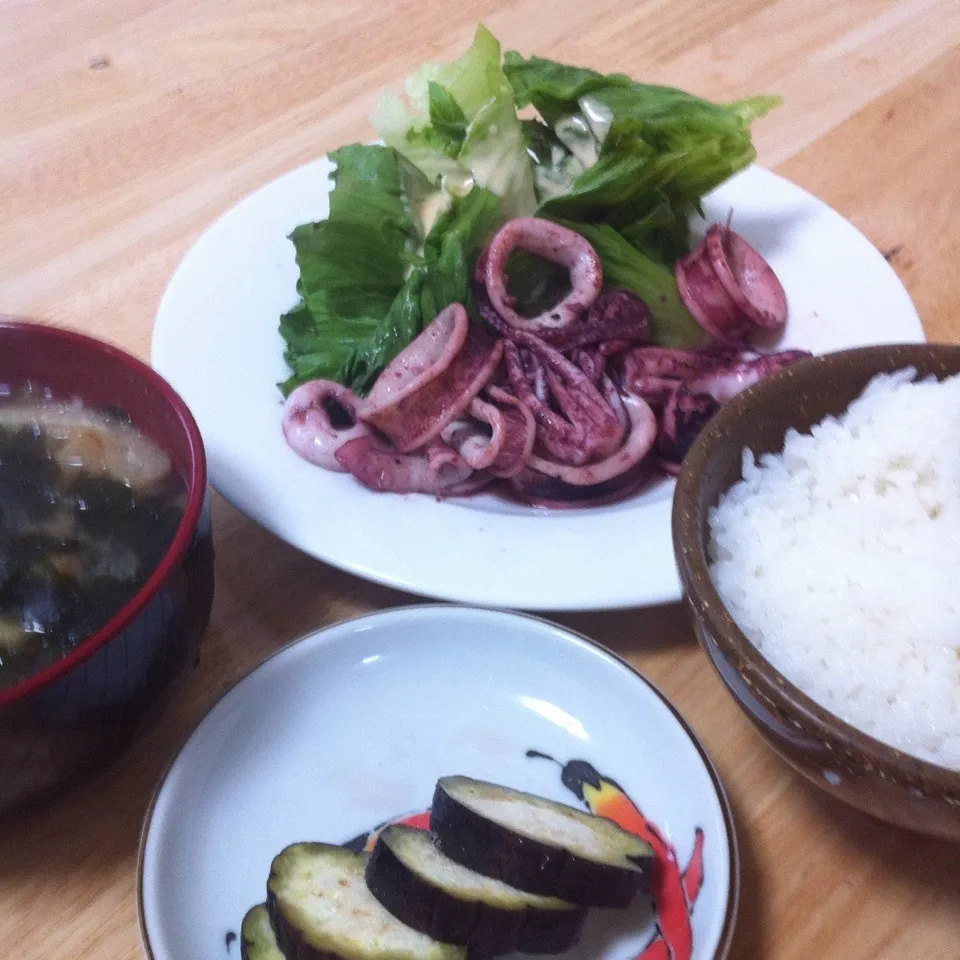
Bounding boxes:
[139,606,738,960]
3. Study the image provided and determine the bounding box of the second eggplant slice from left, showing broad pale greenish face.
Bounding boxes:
[267,843,467,960]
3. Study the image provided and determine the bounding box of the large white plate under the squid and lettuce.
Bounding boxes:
[153,160,923,610]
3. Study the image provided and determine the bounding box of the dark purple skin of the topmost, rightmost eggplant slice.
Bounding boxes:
[430,778,653,912]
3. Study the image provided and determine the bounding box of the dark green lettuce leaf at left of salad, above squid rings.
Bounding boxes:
[280,146,502,395]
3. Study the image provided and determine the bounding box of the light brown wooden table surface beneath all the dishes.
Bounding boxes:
[0,0,960,960]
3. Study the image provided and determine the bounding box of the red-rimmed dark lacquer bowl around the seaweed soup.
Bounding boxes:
[0,318,213,810]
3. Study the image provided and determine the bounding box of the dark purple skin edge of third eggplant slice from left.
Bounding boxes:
[366,827,586,957]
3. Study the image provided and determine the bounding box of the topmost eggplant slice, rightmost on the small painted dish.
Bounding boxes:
[430,777,653,907]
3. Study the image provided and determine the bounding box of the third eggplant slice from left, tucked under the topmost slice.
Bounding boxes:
[367,824,586,955]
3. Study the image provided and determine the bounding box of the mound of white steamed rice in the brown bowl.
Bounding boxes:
[709,370,960,770]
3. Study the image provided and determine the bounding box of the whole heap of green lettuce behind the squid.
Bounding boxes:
[280,26,779,393]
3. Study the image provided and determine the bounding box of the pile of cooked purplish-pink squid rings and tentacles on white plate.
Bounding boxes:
[283,218,808,506]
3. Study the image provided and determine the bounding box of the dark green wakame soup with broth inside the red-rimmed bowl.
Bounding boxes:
[0,399,186,689]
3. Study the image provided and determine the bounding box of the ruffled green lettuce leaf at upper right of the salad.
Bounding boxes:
[504,51,779,263]
